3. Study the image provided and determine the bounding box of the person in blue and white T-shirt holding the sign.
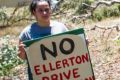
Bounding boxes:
[18,0,67,80]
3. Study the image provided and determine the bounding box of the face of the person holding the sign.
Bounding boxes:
[34,1,51,23]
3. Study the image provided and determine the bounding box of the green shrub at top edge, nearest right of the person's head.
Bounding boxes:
[61,0,94,14]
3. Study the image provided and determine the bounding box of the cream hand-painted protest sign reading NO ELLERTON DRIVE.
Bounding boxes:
[24,29,95,80]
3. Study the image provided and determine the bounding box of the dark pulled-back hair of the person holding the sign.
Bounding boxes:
[29,0,51,14]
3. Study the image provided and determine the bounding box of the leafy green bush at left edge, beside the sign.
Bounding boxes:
[0,36,23,76]
